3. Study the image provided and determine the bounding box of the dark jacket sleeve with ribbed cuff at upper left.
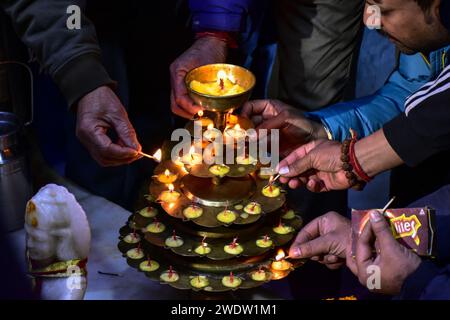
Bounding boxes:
[0,0,114,106]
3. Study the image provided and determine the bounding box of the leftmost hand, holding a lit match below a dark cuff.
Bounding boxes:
[76,86,142,167]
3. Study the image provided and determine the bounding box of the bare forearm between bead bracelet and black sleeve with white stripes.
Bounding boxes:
[355,129,403,177]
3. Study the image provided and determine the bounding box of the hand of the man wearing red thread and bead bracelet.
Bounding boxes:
[278,140,351,192]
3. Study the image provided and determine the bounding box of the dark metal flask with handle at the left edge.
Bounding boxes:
[0,61,33,232]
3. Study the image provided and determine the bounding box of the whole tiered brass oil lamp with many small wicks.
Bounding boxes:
[118,64,303,292]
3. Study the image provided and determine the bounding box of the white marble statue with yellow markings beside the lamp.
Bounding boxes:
[25,184,91,300]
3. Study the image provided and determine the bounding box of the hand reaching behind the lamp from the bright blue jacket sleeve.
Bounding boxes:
[241,100,327,156]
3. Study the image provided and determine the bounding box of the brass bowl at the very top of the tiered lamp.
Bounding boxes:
[185,63,256,113]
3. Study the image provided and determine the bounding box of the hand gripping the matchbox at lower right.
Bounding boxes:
[347,211,421,295]
